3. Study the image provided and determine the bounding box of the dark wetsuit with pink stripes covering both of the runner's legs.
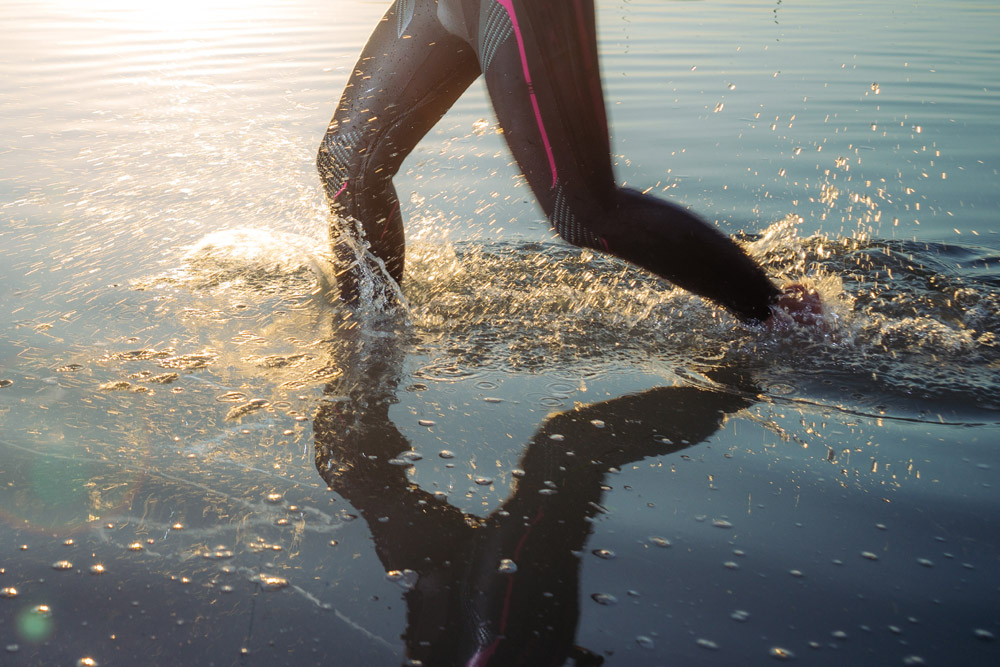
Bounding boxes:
[317,0,779,321]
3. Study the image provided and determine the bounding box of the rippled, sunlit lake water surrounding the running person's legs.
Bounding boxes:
[0,0,1000,665]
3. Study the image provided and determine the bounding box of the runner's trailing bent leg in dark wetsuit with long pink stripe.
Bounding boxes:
[479,0,777,320]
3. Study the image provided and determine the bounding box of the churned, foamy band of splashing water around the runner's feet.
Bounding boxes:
[144,216,1000,422]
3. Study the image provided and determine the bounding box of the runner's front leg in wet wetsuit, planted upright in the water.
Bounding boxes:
[317,0,479,299]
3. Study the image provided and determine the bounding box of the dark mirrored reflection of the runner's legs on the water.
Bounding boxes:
[314,320,753,667]
